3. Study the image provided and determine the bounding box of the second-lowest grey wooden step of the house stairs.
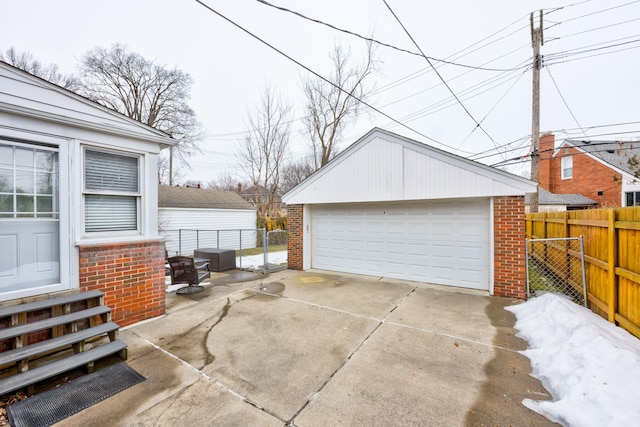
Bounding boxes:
[0,322,119,373]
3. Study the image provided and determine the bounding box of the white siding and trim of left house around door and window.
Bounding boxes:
[0,64,174,301]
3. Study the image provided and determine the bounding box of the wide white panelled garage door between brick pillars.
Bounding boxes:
[311,199,489,290]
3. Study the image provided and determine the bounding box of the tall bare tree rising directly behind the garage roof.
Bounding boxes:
[302,43,378,169]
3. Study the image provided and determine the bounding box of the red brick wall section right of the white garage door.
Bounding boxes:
[493,196,526,299]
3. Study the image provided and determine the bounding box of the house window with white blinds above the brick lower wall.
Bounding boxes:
[83,148,140,233]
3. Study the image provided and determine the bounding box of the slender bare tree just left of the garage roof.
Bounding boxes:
[236,87,291,214]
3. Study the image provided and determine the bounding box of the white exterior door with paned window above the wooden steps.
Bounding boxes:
[0,141,61,295]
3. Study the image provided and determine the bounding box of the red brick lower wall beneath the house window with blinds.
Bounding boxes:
[80,240,166,326]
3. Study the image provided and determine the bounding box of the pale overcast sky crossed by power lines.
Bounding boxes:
[0,0,640,184]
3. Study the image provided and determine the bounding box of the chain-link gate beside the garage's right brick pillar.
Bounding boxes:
[526,236,587,307]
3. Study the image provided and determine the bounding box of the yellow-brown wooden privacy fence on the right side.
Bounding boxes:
[526,207,640,338]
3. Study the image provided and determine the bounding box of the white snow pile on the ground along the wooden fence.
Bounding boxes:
[507,294,640,427]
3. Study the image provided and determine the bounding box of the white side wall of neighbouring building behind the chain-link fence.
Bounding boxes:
[158,208,257,255]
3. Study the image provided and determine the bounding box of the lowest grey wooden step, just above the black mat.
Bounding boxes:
[0,340,127,395]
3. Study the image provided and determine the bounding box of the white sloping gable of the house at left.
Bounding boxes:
[0,61,177,146]
